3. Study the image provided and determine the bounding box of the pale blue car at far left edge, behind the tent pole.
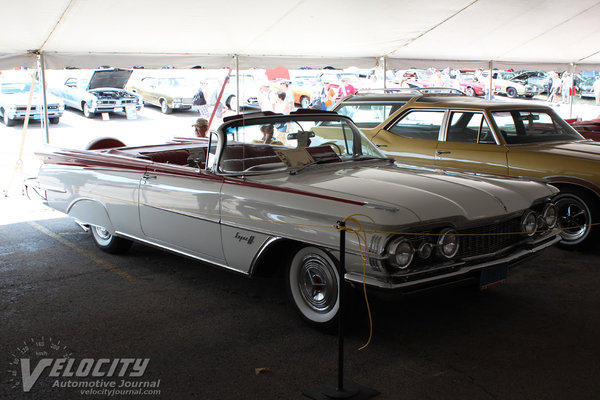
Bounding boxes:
[0,79,65,126]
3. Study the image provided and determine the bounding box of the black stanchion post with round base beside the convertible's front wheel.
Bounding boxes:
[303,221,379,400]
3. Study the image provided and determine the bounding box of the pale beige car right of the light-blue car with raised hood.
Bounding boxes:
[126,76,198,114]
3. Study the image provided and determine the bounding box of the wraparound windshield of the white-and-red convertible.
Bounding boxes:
[219,115,385,173]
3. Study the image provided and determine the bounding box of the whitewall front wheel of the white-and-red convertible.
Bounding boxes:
[286,246,340,329]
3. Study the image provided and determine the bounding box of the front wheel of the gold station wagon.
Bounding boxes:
[554,189,597,248]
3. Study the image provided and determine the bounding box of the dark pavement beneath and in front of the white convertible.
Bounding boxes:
[0,206,600,400]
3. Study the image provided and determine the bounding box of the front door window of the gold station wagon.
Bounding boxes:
[446,111,496,144]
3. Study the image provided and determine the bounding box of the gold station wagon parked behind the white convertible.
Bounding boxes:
[334,93,600,247]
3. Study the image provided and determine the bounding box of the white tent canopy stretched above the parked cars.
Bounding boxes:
[0,0,600,70]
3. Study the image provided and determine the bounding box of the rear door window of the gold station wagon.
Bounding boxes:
[388,111,444,140]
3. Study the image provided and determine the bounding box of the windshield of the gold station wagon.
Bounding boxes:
[492,110,583,144]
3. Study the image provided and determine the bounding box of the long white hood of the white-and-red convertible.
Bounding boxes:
[254,165,558,221]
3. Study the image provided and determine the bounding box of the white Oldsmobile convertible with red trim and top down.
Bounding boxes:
[27,110,559,326]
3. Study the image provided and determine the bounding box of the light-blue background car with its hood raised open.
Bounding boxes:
[49,68,144,118]
